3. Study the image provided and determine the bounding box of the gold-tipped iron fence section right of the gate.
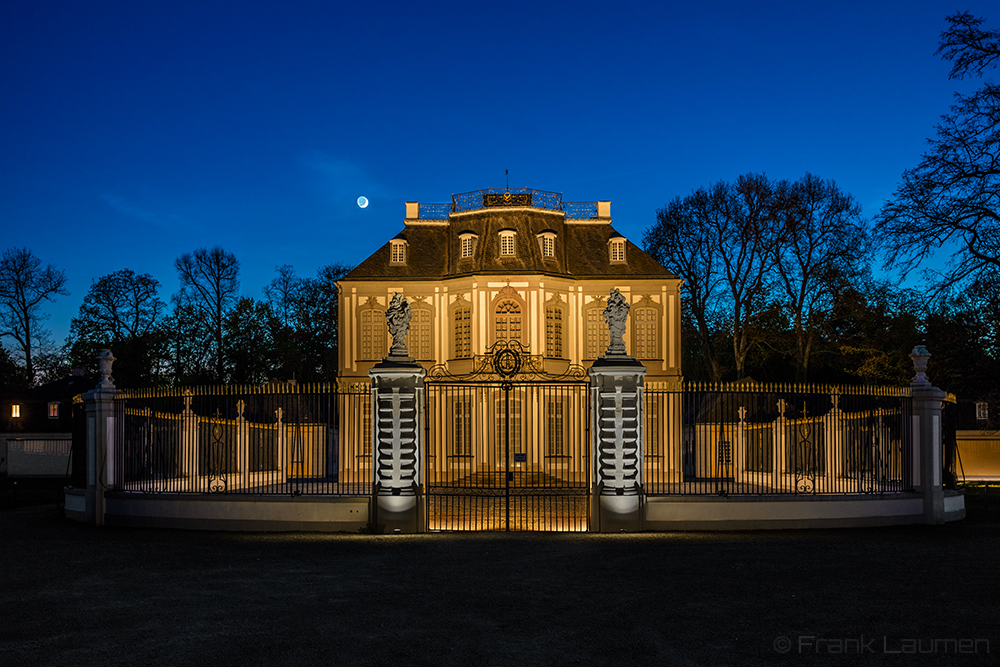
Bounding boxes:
[643,383,914,495]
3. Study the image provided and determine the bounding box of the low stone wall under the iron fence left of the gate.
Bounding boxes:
[66,490,371,532]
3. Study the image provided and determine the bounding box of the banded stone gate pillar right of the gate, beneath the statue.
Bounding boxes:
[588,355,646,533]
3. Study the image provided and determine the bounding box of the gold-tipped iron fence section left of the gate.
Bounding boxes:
[108,382,372,496]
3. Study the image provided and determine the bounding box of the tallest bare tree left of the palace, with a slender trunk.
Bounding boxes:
[174,246,240,382]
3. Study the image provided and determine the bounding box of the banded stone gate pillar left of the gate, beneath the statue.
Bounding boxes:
[368,356,425,533]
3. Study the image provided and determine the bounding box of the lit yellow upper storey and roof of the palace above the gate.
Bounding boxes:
[339,189,681,381]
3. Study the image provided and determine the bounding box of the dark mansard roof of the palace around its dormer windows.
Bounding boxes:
[342,196,676,280]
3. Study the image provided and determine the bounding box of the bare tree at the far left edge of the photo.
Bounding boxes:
[0,248,69,383]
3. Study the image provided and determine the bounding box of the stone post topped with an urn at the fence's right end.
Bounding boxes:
[910,345,946,524]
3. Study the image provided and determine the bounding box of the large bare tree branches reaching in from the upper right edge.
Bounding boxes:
[876,13,1000,288]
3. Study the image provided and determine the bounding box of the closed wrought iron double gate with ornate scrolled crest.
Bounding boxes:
[424,340,590,531]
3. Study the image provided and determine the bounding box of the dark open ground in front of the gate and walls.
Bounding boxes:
[0,505,1000,667]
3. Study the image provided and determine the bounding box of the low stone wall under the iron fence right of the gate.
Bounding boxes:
[643,491,965,531]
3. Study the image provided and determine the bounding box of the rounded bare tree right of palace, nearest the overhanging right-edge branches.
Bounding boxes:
[773,174,868,382]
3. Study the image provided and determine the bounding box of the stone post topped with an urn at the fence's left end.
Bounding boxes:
[83,350,116,526]
